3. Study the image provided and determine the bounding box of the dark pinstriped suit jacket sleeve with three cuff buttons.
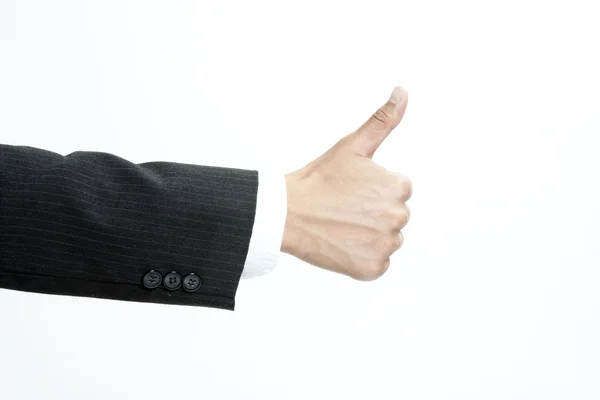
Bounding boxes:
[0,145,258,310]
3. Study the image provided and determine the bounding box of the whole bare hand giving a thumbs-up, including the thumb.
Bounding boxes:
[281,86,412,281]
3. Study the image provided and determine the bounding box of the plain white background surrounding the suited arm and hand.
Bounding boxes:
[0,0,600,400]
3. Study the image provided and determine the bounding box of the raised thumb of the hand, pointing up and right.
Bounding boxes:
[351,86,408,158]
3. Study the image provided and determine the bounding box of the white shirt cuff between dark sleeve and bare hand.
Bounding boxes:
[242,171,287,278]
